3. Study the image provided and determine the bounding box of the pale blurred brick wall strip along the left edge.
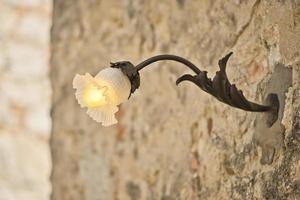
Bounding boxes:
[0,0,52,200]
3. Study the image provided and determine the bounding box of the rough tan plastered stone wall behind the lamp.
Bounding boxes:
[51,0,300,200]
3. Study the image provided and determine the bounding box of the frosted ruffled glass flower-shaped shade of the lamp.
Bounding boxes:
[73,68,131,126]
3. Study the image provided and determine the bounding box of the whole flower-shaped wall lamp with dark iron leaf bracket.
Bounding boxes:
[73,52,279,126]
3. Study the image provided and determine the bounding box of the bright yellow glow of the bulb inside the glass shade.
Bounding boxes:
[83,83,107,108]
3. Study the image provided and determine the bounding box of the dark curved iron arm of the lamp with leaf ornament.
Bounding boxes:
[111,52,278,112]
